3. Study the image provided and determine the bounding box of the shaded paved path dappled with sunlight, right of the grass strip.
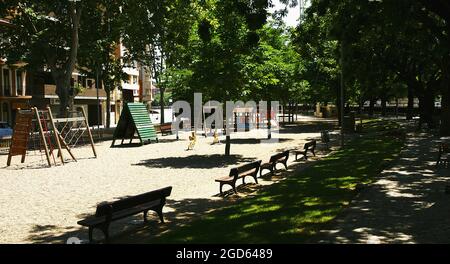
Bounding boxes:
[314,125,450,244]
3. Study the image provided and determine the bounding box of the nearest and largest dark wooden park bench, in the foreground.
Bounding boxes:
[78,187,172,242]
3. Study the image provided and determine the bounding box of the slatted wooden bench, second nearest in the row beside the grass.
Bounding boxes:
[216,160,261,195]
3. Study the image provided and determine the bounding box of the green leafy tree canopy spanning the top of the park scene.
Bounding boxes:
[0,0,450,134]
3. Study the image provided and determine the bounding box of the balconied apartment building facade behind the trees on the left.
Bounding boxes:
[0,16,153,126]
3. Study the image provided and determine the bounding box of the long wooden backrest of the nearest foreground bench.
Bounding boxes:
[95,186,172,216]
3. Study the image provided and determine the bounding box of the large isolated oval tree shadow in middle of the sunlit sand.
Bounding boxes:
[133,154,256,169]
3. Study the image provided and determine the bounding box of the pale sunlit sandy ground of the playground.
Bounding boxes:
[0,118,338,243]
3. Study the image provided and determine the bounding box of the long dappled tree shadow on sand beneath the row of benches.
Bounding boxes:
[23,155,312,244]
